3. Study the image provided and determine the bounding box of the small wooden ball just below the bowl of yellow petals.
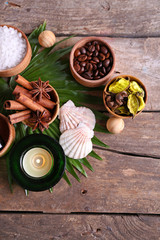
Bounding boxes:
[106,117,124,133]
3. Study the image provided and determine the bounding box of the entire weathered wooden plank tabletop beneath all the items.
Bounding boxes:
[0,0,160,240]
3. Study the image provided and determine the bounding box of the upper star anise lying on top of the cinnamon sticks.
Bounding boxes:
[30,78,52,100]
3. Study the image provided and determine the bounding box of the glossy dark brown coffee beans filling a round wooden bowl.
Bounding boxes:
[74,41,113,80]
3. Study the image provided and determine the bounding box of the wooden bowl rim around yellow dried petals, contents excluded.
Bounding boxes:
[103,75,147,118]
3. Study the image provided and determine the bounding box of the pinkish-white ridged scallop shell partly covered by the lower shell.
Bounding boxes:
[59,100,96,133]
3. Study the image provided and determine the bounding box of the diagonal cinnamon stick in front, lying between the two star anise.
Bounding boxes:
[16,93,51,116]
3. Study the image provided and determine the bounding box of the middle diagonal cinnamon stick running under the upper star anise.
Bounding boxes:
[13,85,58,110]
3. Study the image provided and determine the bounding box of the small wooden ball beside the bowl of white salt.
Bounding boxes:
[38,30,56,48]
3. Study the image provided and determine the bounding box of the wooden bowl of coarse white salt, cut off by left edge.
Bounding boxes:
[0,25,32,77]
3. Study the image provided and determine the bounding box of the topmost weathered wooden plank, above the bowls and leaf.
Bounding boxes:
[0,0,160,36]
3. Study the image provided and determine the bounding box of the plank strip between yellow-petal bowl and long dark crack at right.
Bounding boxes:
[96,112,160,158]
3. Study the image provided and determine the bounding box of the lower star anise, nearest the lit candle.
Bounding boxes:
[28,110,51,132]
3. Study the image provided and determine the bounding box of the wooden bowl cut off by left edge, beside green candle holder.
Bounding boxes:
[0,113,15,157]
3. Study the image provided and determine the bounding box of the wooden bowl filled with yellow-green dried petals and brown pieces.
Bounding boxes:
[103,75,147,118]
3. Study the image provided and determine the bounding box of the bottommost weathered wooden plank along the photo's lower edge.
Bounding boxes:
[0,214,160,240]
